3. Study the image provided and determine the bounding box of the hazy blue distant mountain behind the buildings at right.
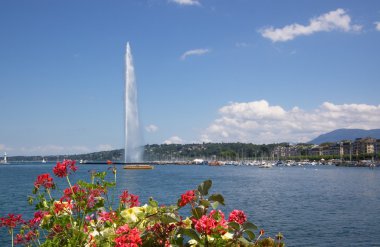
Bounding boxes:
[309,129,380,145]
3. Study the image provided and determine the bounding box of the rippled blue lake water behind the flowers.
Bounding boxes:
[0,164,380,246]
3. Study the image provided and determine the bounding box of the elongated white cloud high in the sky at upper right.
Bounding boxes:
[260,9,362,42]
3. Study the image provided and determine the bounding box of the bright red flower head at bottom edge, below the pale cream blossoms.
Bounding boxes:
[115,224,142,247]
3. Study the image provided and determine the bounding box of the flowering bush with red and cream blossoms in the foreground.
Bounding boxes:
[0,160,284,247]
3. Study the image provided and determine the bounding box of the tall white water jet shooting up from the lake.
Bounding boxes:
[124,42,143,162]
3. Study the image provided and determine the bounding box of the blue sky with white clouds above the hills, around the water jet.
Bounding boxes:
[0,0,380,155]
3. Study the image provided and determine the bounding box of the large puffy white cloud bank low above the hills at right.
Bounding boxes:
[200,100,380,144]
